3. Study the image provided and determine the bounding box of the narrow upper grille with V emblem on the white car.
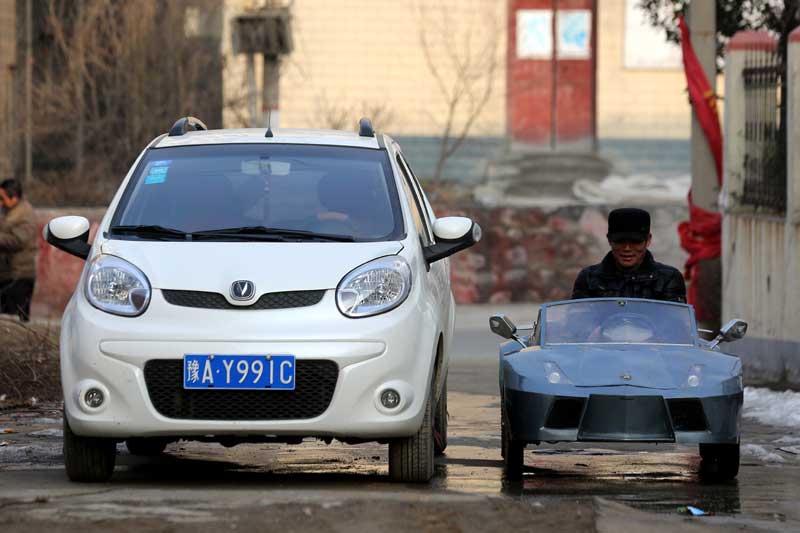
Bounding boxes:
[161,289,325,310]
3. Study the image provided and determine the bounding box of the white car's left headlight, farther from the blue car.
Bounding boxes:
[86,255,151,316]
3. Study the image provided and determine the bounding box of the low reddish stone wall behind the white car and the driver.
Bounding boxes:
[25,201,686,318]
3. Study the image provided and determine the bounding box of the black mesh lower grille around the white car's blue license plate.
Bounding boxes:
[144,359,339,420]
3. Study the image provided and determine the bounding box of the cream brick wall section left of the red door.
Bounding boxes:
[223,0,505,136]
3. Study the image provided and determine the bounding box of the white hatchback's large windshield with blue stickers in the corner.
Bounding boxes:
[112,144,403,241]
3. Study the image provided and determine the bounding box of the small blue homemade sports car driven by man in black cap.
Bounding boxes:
[489,298,747,480]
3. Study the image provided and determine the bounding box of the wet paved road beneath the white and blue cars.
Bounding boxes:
[0,306,800,533]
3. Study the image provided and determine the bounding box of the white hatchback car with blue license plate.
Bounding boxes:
[44,117,480,482]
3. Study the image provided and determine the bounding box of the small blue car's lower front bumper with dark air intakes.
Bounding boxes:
[503,387,743,444]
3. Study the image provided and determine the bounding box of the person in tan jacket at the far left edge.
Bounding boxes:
[0,178,38,322]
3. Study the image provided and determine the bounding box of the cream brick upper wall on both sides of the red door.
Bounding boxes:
[223,0,690,143]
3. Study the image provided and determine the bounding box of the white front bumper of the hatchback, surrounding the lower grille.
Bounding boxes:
[61,290,441,439]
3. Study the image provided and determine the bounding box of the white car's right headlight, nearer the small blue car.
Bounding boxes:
[336,255,411,318]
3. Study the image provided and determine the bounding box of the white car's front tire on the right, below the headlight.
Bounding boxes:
[389,386,434,483]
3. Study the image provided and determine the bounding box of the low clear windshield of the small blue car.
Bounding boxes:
[543,299,695,345]
